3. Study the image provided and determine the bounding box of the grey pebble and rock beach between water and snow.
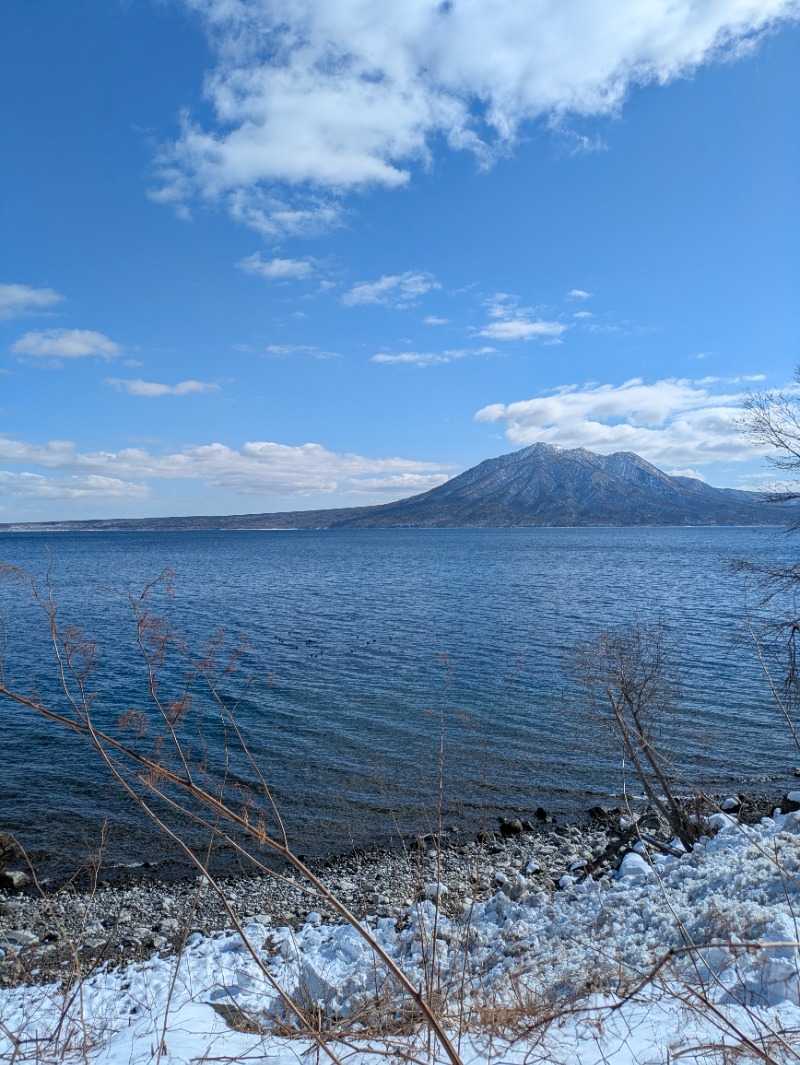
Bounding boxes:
[0,798,780,986]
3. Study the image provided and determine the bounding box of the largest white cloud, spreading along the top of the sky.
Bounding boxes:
[152,0,799,236]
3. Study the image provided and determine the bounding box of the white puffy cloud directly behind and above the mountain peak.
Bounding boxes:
[475,378,753,469]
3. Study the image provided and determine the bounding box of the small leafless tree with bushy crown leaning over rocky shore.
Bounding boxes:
[575,620,700,849]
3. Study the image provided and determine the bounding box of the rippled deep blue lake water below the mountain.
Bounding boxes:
[0,528,798,873]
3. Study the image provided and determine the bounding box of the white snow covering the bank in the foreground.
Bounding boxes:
[0,814,800,1065]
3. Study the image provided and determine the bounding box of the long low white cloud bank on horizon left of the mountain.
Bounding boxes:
[0,437,448,497]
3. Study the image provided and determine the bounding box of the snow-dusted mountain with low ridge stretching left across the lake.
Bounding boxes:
[0,444,797,531]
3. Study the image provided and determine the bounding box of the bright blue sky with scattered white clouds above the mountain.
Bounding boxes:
[0,0,800,521]
